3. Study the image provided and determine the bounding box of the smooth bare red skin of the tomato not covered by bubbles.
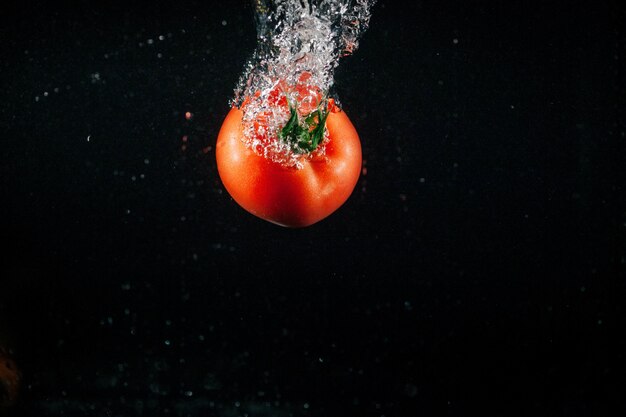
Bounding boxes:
[215,107,362,227]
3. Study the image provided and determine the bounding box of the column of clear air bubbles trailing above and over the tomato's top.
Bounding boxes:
[231,0,376,168]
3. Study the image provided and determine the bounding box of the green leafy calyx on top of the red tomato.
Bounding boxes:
[278,105,329,154]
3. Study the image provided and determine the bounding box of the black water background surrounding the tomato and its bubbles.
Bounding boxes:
[0,0,626,417]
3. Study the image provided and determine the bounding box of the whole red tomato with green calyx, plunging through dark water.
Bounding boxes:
[216,73,362,227]
